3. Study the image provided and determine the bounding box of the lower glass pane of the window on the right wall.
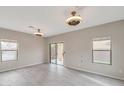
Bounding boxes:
[93,51,110,64]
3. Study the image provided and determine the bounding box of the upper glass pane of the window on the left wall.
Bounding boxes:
[1,41,17,50]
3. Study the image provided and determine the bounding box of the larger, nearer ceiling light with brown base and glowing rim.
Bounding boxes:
[66,11,82,26]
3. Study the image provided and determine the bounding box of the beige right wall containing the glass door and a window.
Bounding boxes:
[47,20,124,79]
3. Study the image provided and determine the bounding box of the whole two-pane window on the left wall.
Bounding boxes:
[0,40,18,62]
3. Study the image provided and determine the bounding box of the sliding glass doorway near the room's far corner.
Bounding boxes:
[50,42,64,65]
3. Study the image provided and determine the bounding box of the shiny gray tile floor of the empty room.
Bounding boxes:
[0,64,124,86]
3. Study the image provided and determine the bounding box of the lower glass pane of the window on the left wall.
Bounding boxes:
[2,51,17,61]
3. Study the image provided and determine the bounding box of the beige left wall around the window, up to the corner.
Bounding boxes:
[0,28,47,72]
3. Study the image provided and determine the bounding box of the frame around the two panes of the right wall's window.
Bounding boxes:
[92,37,112,65]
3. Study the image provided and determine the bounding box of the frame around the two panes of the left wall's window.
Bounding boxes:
[0,39,18,62]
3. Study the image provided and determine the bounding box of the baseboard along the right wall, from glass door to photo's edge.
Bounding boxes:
[65,66,124,80]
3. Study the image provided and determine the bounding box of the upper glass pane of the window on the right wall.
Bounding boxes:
[93,40,111,50]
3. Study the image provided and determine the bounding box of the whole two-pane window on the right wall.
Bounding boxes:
[92,37,112,64]
